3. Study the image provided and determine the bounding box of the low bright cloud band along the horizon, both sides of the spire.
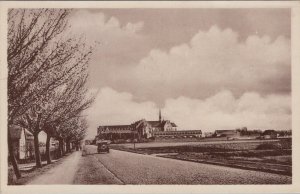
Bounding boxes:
[88,87,291,136]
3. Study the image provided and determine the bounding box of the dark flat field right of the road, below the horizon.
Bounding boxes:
[111,139,292,176]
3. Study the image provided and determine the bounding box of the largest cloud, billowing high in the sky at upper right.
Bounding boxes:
[134,26,291,101]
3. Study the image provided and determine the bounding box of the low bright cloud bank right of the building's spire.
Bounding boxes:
[163,90,291,131]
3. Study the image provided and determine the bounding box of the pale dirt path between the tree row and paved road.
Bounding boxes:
[27,151,81,185]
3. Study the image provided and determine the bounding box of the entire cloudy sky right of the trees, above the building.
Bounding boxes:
[70,9,291,137]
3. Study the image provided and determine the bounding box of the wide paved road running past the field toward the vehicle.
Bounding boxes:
[77,146,292,184]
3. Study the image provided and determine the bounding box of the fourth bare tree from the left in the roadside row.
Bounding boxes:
[44,72,95,155]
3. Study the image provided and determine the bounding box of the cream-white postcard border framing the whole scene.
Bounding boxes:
[0,1,300,194]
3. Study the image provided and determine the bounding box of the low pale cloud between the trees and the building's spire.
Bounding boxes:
[87,87,158,136]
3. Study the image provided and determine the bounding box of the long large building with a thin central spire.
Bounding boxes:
[96,111,202,140]
